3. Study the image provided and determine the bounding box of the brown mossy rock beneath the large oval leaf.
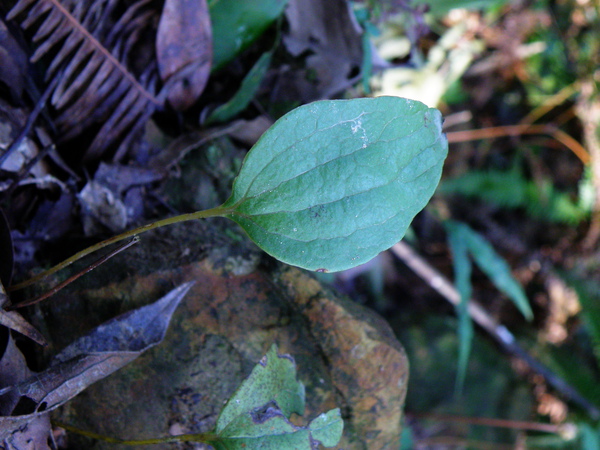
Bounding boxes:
[33,134,408,450]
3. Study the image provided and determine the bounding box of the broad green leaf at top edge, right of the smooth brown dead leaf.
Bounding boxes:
[208,0,289,70]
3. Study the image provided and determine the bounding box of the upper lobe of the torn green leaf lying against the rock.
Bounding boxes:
[215,345,304,434]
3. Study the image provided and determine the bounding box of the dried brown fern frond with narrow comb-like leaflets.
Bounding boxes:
[7,0,164,160]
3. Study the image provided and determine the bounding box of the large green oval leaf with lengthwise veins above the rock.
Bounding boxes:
[223,97,448,272]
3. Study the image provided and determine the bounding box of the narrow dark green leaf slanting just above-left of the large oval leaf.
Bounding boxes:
[206,52,272,124]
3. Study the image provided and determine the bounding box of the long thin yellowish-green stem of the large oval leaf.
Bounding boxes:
[7,206,231,292]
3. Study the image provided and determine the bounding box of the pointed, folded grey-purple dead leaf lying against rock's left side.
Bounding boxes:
[0,282,193,444]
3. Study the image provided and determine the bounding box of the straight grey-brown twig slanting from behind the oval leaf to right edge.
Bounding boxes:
[391,242,600,419]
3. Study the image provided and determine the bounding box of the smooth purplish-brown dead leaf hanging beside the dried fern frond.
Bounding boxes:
[156,0,212,111]
